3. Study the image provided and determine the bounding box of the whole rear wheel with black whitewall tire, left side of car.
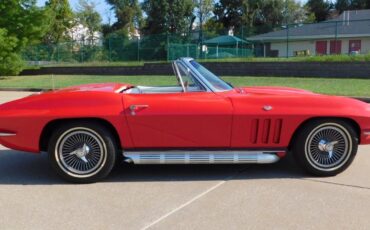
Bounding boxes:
[48,122,118,183]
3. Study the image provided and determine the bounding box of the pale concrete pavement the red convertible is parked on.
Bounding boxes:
[0,92,370,229]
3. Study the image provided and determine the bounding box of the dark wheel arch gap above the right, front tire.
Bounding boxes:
[288,117,361,150]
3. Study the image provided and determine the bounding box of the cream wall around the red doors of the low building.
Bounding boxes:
[271,37,370,57]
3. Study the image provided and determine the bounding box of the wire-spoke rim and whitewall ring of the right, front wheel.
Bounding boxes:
[305,123,353,171]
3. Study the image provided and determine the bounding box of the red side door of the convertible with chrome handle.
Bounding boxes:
[123,92,233,148]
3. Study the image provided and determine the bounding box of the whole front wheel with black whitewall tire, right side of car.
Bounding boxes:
[292,119,358,177]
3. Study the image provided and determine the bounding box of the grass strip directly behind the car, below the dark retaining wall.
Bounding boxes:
[0,75,370,97]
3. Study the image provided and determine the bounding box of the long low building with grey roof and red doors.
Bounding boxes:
[248,10,370,57]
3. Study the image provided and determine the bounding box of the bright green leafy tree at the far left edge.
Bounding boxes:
[0,0,46,75]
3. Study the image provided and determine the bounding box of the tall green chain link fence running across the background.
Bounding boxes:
[22,19,370,64]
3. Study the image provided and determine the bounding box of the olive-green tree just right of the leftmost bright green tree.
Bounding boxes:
[43,0,74,44]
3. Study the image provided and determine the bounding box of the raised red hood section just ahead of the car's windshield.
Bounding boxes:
[241,86,315,95]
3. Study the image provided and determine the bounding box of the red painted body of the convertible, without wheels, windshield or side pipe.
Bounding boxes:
[0,83,370,153]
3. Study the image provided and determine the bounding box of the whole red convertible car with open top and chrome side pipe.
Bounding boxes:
[0,58,370,183]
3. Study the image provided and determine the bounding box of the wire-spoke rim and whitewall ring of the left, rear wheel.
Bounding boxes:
[55,127,107,178]
